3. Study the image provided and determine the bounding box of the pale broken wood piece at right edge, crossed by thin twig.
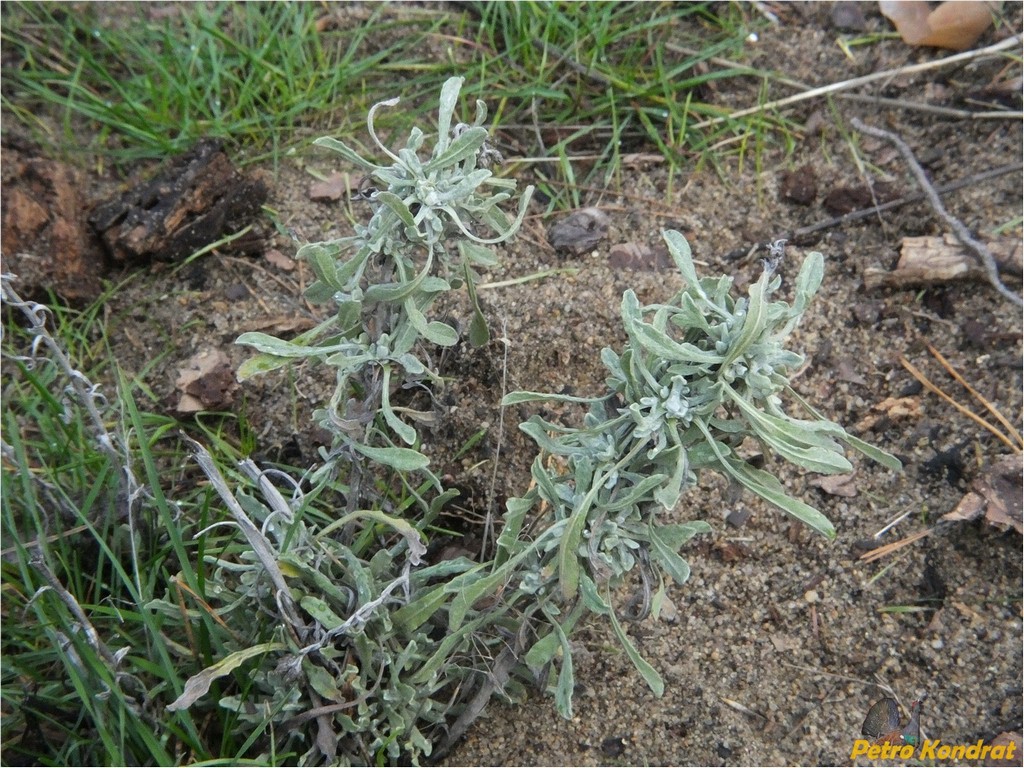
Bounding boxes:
[864,234,1022,290]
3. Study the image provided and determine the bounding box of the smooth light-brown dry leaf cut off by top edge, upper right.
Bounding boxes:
[879,0,1002,50]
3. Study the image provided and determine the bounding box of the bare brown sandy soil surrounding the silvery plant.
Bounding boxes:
[6,5,1022,765]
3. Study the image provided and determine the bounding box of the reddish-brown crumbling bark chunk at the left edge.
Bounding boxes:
[0,151,106,303]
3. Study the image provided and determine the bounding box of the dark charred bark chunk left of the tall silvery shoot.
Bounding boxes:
[89,139,267,264]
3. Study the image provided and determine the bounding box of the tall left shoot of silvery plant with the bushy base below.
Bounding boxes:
[176,78,544,764]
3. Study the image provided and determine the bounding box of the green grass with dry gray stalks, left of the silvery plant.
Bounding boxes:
[0,274,282,765]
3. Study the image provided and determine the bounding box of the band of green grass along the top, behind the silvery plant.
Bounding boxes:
[2,2,785,193]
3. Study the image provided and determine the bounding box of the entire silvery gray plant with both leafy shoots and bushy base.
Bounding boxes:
[184,78,899,764]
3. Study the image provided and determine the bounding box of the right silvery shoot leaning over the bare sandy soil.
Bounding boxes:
[500,231,900,714]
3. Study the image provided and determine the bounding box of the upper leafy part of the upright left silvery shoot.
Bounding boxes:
[238,73,532,481]
